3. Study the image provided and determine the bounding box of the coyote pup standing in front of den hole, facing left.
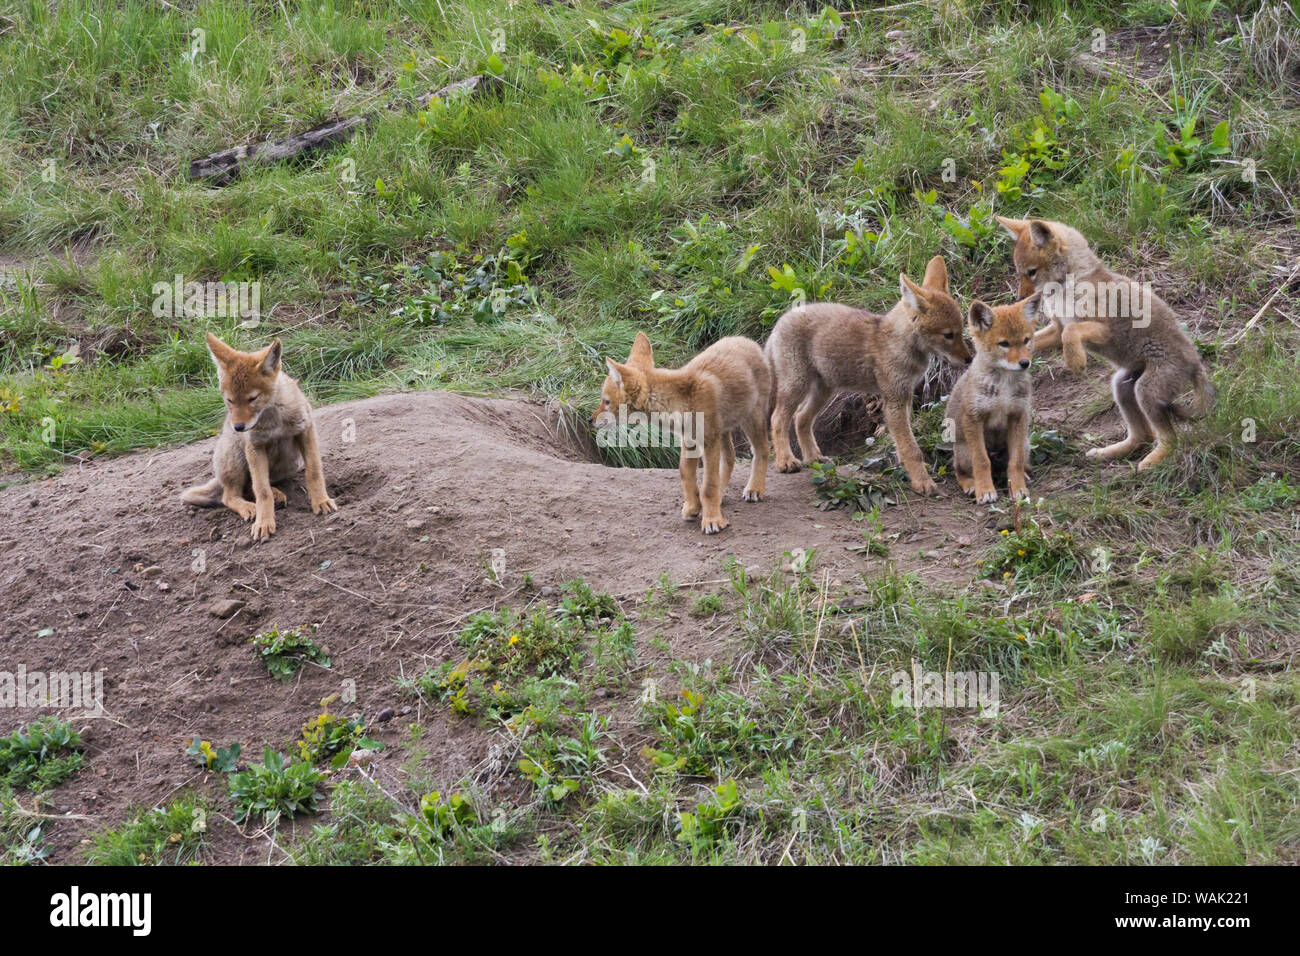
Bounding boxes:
[592,332,772,535]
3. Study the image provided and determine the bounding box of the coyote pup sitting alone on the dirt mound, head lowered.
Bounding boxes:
[181,332,338,541]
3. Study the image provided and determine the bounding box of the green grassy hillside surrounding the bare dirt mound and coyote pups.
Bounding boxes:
[0,0,1300,864]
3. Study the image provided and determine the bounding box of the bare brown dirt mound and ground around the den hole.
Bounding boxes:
[0,385,1118,862]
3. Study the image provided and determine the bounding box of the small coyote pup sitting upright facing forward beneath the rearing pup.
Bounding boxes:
[945,293,1040,505]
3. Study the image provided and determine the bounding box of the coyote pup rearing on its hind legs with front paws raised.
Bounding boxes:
[998,216,1214,471]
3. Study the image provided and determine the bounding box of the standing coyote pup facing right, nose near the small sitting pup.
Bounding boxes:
[764,256,971,494]
